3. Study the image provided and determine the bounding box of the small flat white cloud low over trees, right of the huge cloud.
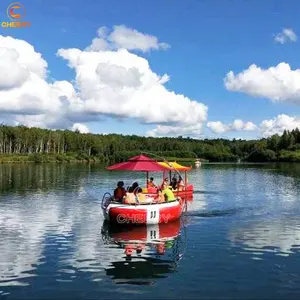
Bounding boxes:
[207,119,257,134]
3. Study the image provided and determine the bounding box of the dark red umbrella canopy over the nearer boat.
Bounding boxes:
[106,155,170,172]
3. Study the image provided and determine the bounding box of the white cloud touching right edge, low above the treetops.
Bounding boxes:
[259,114,300,137]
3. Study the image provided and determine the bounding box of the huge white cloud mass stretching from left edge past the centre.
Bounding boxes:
[0,26,208,134]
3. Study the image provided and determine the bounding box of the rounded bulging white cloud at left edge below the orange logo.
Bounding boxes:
[0,36,72,115]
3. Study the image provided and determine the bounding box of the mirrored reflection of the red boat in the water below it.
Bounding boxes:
[102,220,186,285]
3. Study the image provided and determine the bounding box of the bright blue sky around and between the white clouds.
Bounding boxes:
[0,0,300,138]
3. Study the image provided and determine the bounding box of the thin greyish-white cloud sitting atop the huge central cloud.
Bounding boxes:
[87,25,170,52]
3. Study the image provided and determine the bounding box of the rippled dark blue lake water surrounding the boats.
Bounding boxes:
[0,164,300,299]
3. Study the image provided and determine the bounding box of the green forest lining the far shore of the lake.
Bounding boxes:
[0,125,300,164]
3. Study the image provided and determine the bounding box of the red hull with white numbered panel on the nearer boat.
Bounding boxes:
[103,199,184,225]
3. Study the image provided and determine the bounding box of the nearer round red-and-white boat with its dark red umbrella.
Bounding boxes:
[102,155,193,224]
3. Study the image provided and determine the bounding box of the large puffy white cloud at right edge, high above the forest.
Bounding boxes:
[224,63,300,104]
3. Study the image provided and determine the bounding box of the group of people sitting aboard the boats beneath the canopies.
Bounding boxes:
[113,177,184,204]
